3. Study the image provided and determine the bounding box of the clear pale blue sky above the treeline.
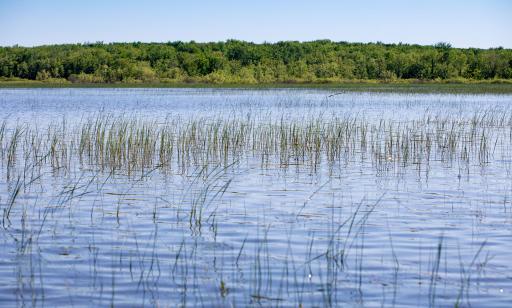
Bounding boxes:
[0,0,512,48]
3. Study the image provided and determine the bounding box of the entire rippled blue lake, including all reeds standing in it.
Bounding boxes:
[0,89,512,307]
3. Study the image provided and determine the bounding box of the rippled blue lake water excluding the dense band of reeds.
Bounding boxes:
[0,89,512,307]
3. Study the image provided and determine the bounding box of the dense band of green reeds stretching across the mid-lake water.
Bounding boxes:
[0,111,512,177]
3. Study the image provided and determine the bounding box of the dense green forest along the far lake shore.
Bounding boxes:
[0,40,512,84]
